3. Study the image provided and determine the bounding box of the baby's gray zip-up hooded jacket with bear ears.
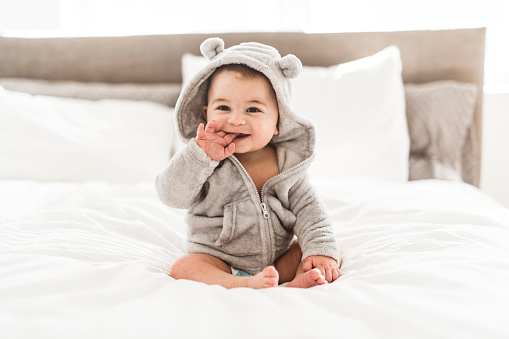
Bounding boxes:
[156,38,339,274]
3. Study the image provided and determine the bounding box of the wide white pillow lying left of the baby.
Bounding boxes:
[0,88,175,183]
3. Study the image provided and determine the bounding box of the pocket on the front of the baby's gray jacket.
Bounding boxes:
[215,198,261,255]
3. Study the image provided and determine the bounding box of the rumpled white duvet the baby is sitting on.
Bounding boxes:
[0,180,509,339]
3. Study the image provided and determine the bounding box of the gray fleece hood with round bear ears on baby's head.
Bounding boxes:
[175,38,315,159]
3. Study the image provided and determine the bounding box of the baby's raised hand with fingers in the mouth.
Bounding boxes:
[196,120,236,161]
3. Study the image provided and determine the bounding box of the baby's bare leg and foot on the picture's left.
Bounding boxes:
[170,254,279,288]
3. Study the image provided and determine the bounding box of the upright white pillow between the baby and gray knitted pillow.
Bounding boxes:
[292,46,410,182]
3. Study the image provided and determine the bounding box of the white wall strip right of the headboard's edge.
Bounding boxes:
[481,93,509,208]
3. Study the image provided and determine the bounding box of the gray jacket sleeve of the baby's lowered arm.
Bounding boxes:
[292,175,339,264]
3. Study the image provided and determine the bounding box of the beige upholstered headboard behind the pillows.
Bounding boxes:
[0,28,485,185]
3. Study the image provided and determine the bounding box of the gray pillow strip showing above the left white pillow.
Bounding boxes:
[0,78,181,107]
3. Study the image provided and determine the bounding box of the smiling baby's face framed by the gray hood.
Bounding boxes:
[203,69,279,153]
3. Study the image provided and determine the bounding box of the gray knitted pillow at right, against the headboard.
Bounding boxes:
[405,81,477,183]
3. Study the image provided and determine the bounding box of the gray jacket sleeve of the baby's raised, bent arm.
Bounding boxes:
[156,139,219,208]
